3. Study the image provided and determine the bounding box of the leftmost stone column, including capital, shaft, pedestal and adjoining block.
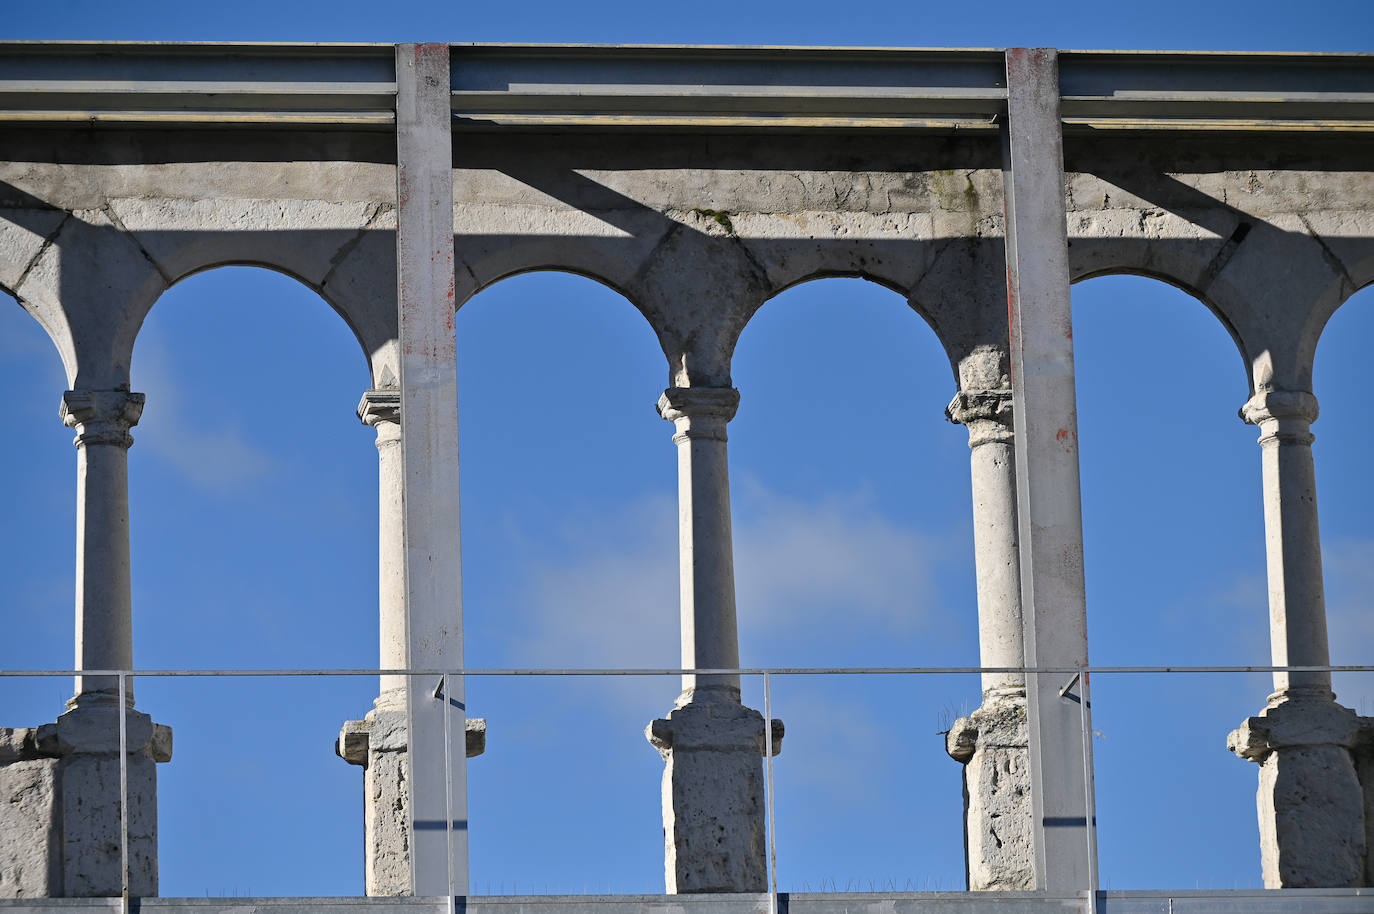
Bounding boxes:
[0,390,172,898]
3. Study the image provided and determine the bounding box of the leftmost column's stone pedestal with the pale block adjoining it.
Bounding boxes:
[0,704,172,898]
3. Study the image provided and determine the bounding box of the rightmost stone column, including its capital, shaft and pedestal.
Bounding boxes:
[1227,390,1366,888]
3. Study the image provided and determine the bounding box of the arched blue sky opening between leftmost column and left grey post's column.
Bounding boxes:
[129,262,378,893]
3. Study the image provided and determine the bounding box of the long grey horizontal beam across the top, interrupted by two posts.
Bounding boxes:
[0,41,1374,131]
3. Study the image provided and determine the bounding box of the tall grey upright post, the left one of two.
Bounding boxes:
[396,44,467,896]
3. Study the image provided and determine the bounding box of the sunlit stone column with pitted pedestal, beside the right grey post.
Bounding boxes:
[945,390,1035,891]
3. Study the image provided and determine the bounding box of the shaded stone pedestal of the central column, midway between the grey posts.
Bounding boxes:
[644,689,785,895]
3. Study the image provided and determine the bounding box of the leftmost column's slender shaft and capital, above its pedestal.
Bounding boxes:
[60,390,143,708]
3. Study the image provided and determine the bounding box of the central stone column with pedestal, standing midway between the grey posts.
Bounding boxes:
[644,388,783,895]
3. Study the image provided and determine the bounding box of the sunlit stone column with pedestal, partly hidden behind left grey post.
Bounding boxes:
[335,388,486,895]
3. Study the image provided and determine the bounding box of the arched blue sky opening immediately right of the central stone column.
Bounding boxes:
[730,275,978,881]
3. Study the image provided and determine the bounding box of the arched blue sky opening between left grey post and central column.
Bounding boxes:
[456,268,679,892]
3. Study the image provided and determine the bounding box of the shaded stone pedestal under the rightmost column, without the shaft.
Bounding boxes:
[1227,695,1369,888]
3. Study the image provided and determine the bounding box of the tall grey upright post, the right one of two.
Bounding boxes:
[1003,48,1095,892]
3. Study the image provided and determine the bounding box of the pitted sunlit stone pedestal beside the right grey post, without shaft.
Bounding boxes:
[945,689,1035,892]
